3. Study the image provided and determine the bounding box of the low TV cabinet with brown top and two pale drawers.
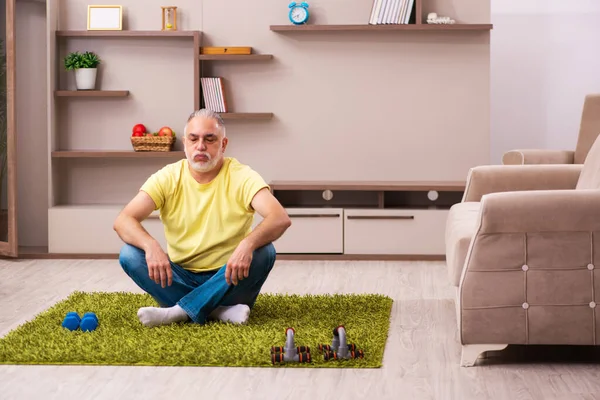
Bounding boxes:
[270,181,466,260]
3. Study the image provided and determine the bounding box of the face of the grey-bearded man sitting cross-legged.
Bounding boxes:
[184,117,227,172]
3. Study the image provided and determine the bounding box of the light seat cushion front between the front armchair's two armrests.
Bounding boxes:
[446,202,481,287]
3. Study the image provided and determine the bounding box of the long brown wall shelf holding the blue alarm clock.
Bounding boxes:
[270,24,493,32]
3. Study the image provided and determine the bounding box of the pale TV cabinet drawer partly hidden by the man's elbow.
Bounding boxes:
[254,208,344,254]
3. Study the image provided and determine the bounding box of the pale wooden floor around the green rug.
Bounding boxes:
[0,260,600,400]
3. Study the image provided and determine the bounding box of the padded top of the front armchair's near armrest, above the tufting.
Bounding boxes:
[479,189,600,234]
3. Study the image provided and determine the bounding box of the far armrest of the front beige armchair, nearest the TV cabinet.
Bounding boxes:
[463,164,583,201]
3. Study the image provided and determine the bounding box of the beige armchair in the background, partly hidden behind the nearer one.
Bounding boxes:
[502,93,600,165]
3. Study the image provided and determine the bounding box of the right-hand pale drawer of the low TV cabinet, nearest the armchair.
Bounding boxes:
[344,209,448,255]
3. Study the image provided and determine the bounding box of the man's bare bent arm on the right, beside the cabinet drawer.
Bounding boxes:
[243,188,292,251]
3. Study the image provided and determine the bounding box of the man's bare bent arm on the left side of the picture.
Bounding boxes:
[113,191,160,252]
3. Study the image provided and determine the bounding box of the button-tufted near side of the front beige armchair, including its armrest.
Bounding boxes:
[459,189,600,345]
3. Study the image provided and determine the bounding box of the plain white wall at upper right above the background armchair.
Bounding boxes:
[491,0,600,163]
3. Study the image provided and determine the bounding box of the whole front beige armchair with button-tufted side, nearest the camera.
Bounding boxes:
[445,134,600,366]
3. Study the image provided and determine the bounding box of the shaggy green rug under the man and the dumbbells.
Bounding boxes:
[0,292,392,368]
